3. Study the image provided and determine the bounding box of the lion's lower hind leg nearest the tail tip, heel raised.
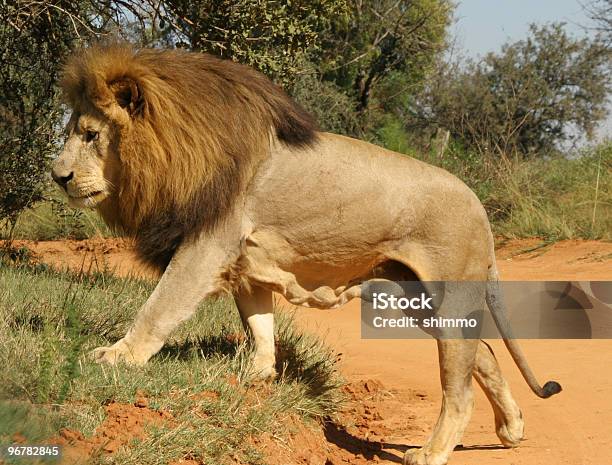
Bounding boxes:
[474,341,524,447]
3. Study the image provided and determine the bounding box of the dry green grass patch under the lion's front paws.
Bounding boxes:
[0,261,341,465]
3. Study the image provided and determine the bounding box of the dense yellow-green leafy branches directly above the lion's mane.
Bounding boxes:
[162,0,346,84]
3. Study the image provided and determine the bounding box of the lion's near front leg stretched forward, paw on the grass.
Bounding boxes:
[93,240,237,365]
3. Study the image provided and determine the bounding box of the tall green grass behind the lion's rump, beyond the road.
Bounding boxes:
[430,140,612,241]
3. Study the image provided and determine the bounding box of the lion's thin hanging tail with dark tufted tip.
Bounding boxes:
[486,256,561,399]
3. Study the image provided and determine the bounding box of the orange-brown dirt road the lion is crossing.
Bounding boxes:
[5,240,612,465]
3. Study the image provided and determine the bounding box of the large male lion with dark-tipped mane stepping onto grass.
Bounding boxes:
[52,44,561,465]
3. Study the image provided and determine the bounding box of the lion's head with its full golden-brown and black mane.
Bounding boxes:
[52,44,316,268]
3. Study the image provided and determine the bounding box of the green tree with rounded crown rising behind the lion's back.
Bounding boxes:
[320,0,453,132]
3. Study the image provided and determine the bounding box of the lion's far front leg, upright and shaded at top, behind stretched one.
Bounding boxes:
[236,286,276,379]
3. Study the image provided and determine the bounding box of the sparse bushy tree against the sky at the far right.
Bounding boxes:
[413,24,611,156]
